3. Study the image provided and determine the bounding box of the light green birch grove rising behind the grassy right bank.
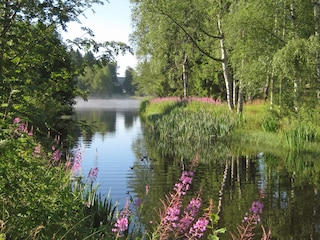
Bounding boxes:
[130,0,320,113]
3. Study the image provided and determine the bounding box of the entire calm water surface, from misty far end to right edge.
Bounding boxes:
[72,100,320,240]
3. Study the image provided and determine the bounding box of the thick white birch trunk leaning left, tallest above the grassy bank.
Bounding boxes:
[218,15,233,111]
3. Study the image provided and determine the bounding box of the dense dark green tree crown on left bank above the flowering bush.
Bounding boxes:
[0,23,77,141]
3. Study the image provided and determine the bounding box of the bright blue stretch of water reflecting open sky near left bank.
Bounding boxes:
[75,109,141,205]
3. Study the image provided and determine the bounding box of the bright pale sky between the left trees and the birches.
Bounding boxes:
[61,0,137,77]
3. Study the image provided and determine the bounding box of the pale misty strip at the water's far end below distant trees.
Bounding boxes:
[74,98,140,110]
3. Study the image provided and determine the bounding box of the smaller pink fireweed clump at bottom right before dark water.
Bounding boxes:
[231,201,271,240]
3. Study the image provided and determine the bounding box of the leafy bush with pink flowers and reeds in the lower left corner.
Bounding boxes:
[0,119,114,239]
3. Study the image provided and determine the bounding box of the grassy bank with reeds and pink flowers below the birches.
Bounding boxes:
[140,98,320,156]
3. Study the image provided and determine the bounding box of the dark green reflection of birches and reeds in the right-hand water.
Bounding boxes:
[132,125,320,240]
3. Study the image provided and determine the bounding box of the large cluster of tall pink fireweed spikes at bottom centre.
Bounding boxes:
[151,157,212,239]
